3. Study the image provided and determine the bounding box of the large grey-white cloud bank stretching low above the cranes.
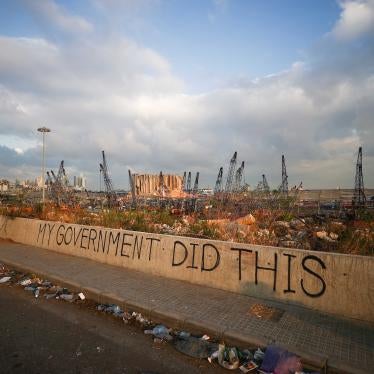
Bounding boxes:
[0,0,374,187]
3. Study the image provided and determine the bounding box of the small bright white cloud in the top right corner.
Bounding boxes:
[333,0,374,40]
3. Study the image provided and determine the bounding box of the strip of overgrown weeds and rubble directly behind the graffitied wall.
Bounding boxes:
[0,201,374,255]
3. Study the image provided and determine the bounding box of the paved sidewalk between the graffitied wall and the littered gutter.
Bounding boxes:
[0,240,374,373]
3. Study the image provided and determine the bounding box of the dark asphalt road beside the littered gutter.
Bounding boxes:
[0,284,226,374]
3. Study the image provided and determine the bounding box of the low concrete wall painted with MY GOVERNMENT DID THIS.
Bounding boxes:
[0,217,374,321]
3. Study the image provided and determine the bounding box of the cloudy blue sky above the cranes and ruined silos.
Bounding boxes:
[0,0,374,189]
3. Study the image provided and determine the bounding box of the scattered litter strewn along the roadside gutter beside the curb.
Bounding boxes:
[0,264,318,374]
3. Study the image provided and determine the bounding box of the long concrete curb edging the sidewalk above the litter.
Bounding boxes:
[1,260,367,374]
